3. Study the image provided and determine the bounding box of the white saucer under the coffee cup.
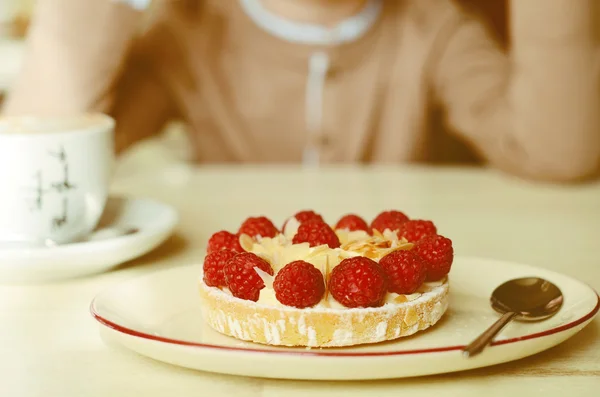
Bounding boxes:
[0,197,177,283]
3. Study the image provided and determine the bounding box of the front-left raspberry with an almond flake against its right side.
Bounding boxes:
[223,252,273,302]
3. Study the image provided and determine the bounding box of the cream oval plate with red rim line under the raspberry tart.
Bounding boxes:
[91,257,600,380]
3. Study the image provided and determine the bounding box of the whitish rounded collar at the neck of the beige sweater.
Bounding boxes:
[239,0,382,45]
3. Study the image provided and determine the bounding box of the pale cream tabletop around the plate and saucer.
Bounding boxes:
[0,150,600,397]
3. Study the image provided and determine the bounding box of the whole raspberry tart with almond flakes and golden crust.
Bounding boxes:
[199,210,454,347]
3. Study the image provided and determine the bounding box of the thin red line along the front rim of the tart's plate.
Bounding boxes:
[90,287,600,357]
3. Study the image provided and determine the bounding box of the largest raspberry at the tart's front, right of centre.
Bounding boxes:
[329,256,387,307]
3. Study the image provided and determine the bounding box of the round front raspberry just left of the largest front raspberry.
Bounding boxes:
[273,261,325,309]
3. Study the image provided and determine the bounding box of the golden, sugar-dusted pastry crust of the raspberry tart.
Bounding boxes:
[199,278,449,347]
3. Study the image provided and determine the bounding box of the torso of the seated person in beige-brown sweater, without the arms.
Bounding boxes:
[145,0,478,163]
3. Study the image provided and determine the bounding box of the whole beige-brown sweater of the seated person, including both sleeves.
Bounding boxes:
[5,0,600,181]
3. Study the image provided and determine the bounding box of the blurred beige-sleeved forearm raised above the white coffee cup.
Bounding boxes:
[5,0,149,114]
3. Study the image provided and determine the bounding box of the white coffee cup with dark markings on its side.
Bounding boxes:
[0,114,114,245]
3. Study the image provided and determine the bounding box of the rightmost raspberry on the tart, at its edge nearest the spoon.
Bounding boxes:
[413,234,454,281]
